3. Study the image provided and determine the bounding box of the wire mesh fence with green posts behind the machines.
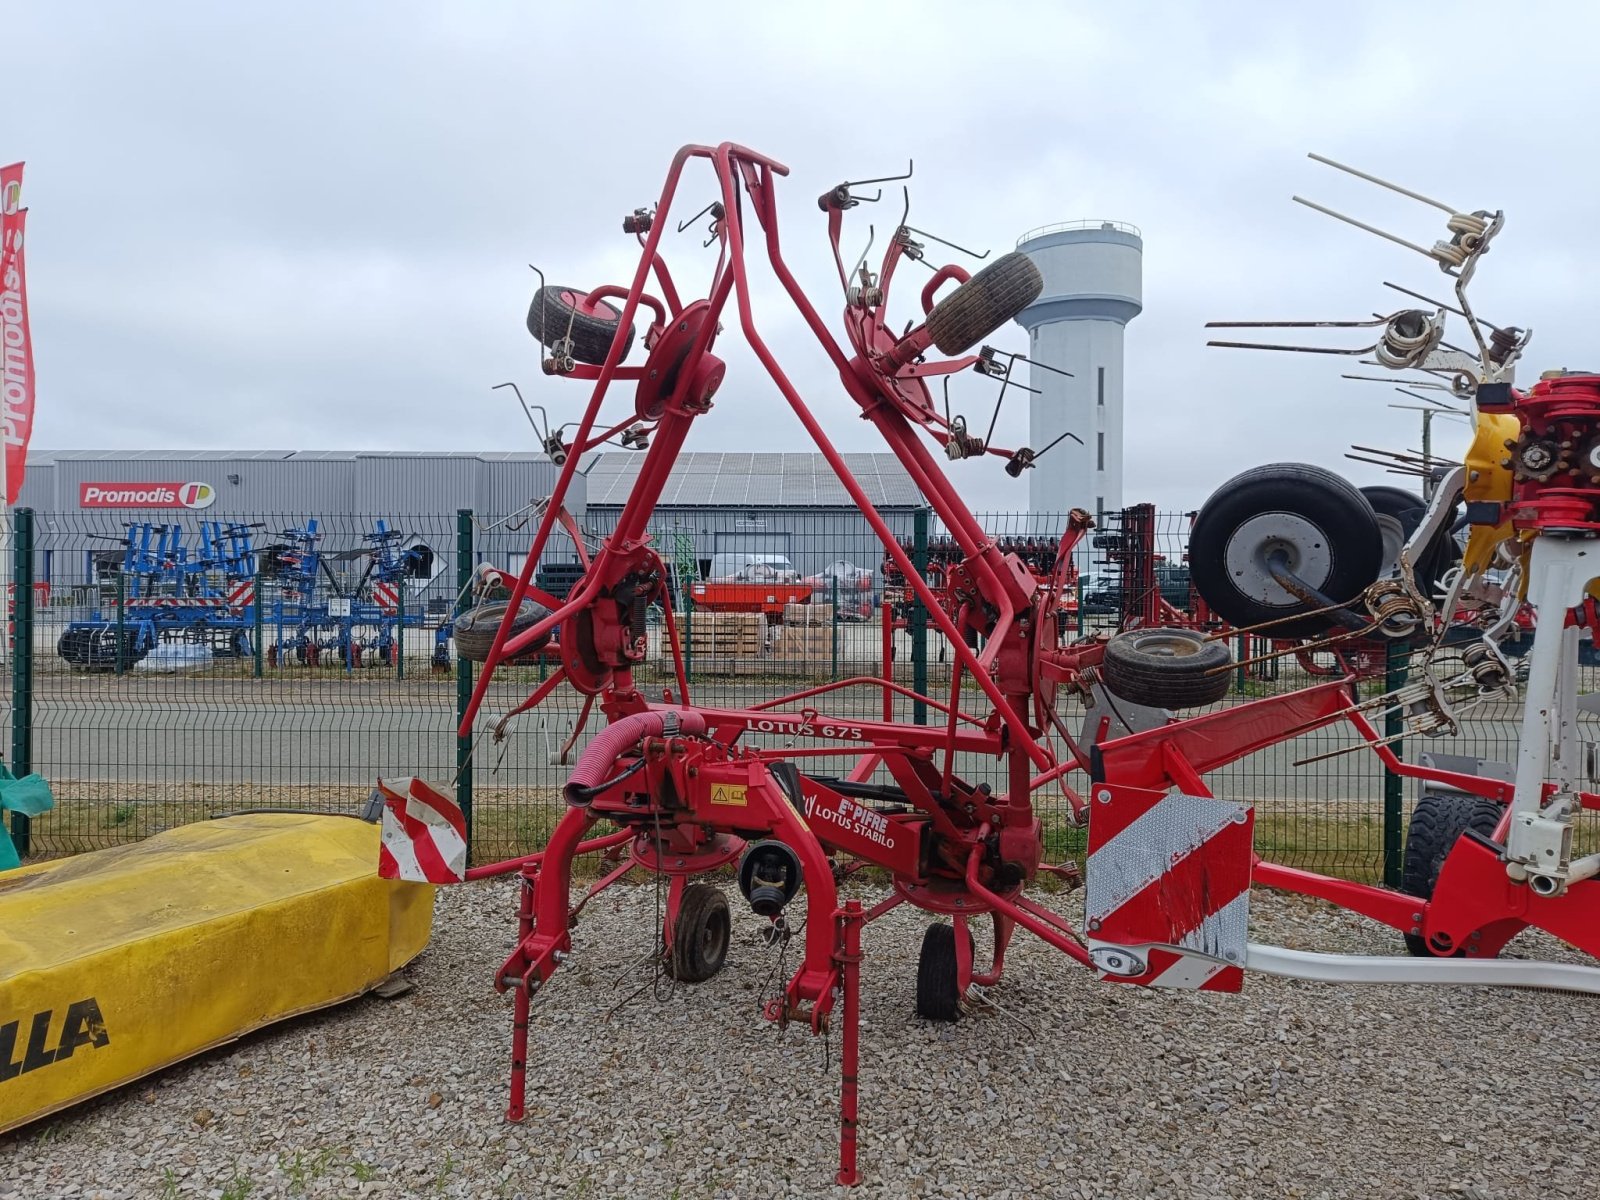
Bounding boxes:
[10,507,1600,878]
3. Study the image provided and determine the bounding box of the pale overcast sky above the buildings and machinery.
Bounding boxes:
[0,0,1600,509]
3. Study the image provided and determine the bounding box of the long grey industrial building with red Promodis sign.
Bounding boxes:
[19,451,922,602]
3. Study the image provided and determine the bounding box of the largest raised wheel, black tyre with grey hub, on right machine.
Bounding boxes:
[1189,462,1384,638]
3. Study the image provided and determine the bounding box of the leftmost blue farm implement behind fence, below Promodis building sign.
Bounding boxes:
[56,522,258,670]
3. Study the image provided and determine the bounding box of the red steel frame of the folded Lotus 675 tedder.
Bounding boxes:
[461,144,1099,1182]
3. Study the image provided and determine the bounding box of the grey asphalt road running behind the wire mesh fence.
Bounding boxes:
[18,677,1555,814]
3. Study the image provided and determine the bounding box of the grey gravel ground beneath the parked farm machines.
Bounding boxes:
[0,882,1600,1200]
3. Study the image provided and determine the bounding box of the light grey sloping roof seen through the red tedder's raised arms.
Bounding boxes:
[587,453,922,509]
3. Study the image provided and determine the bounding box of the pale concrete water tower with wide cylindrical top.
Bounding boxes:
[1016,221,1144,533]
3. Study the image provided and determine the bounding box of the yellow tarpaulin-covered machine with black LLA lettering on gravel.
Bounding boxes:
[0,813,434,1133]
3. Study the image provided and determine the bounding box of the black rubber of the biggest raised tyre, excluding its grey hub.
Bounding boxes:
[1189,462,1384,638]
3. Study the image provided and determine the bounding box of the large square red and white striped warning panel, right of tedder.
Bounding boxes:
[1083,784,1256,992]
